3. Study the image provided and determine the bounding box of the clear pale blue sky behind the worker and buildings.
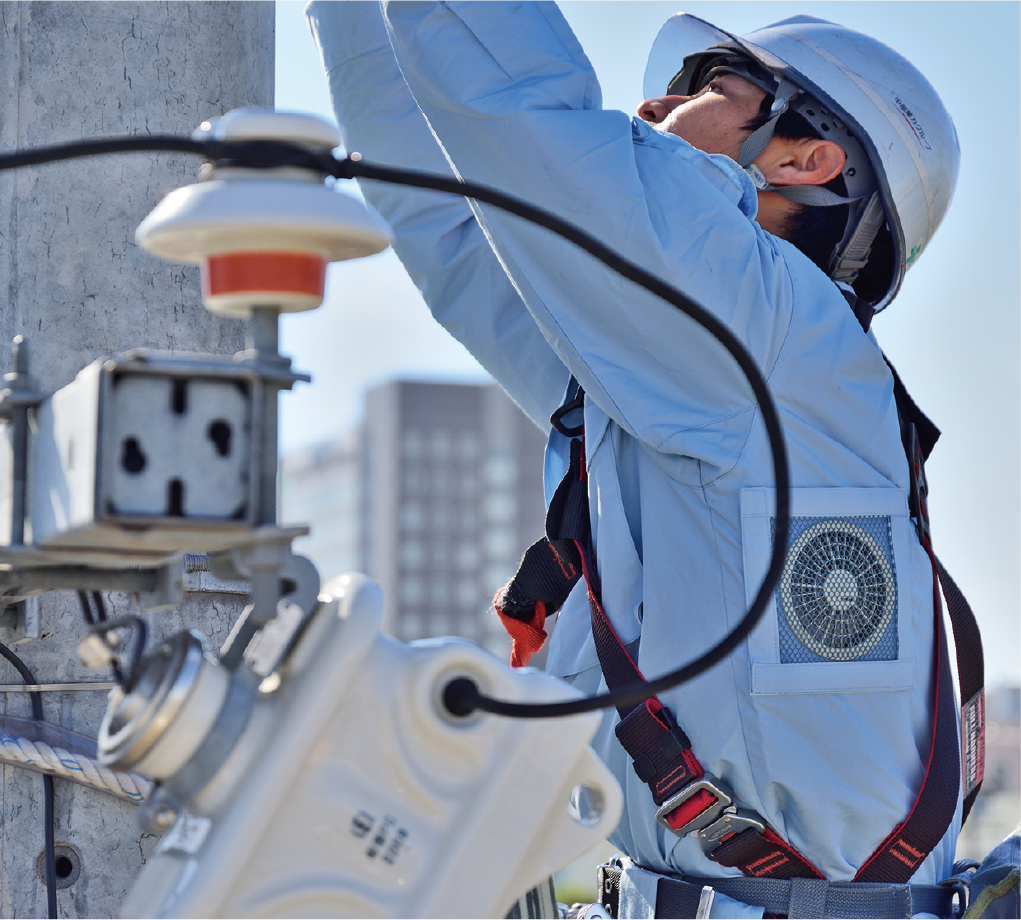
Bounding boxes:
[276,0,1021,686]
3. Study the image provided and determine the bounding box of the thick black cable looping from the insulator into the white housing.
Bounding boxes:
[0,135,790,719]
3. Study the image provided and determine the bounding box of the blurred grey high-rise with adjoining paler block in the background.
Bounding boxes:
[281,381,545,657]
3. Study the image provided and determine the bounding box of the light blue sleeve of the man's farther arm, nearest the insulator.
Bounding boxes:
[306,0,570,429]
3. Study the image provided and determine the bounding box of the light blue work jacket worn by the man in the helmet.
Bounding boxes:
[308,0,960,918]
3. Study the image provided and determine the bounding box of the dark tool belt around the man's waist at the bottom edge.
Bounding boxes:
[598,860,963,920]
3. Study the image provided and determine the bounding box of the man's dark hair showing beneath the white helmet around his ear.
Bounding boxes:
[745,101,893,303]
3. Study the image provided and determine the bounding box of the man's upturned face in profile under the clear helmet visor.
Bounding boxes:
[638,74,766,160]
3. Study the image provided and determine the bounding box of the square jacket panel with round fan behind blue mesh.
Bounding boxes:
[741,488,918,693]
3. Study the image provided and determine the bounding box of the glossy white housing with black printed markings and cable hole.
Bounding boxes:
[113,576,622,920]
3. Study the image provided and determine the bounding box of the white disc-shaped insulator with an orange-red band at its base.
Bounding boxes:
[135,108,392,316]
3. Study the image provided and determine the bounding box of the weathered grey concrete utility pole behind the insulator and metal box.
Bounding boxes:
[0,0,274,920]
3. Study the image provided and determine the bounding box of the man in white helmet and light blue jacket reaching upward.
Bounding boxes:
[307,0,976,920]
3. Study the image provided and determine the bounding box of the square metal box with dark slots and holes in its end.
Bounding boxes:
[27,351,261,555]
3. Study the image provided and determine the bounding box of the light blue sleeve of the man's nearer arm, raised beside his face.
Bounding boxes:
[383,0,793,449]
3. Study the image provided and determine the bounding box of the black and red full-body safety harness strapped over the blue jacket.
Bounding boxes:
[494,302,984,920]
